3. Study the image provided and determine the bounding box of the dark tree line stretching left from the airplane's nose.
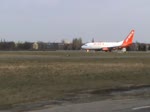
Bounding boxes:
[0,38,82,51]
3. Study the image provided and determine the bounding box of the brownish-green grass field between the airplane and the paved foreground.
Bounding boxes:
[0,51,150,109]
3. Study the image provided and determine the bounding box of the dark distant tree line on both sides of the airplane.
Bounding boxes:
[0,38,150,51]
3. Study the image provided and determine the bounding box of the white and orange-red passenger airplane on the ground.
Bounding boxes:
[81,30,134,52]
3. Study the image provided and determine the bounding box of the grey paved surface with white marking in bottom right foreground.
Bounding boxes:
[28,99,150,112]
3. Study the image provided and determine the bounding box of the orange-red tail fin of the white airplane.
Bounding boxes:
[122,30,134,47]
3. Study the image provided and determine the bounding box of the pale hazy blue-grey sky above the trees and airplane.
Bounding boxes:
[0,0,150,43]
